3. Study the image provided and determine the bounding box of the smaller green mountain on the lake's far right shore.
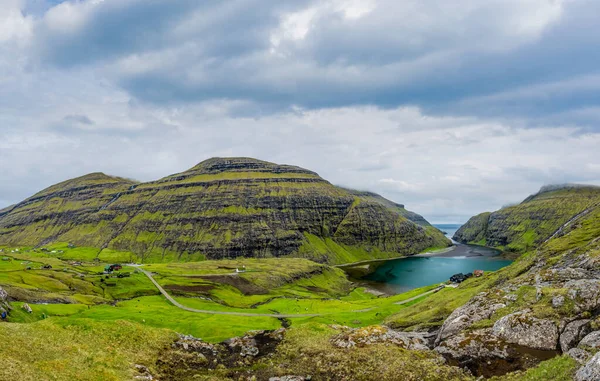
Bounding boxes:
[453,184,600,252]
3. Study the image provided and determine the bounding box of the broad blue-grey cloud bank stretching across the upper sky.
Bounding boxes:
[18,0,600,123]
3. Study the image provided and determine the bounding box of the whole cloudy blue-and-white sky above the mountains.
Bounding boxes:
[0,0,600,223]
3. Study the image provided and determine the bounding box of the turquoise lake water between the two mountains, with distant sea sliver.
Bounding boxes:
[363,225,512,292]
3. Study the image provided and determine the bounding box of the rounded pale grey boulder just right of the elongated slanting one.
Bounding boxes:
[492,312,558,351]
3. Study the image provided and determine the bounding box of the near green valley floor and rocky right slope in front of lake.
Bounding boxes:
[0,181,600,381]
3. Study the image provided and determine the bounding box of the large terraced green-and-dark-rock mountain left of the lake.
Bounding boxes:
[0,158,450,263]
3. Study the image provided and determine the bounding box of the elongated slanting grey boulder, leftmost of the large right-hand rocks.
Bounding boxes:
[435,294,506,346]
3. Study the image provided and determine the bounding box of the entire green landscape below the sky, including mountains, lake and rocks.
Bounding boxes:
[0,158,600,381]
